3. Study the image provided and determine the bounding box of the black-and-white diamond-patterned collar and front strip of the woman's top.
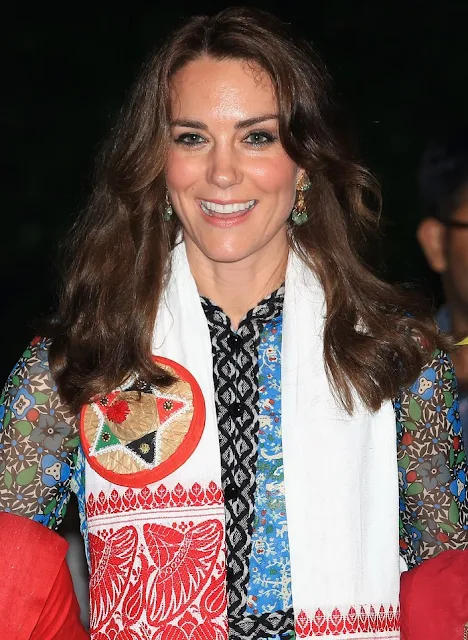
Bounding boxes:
[202,285,294,640]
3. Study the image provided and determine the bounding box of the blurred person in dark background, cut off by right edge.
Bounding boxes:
[417,128,468,451]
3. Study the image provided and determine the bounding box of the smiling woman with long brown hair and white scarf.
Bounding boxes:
[2,9,468,640]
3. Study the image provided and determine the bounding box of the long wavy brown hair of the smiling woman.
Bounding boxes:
[49,8,442,411]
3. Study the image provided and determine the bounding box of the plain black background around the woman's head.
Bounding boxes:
[0,0,468,377]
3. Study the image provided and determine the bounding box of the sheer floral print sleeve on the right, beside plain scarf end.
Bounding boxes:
[395,350,468,567]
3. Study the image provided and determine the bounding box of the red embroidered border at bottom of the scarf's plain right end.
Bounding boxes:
[296,605,400,638]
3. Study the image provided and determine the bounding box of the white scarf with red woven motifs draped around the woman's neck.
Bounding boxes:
[86,243,400,640]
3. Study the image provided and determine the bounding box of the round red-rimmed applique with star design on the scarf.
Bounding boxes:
[80,357,205,487]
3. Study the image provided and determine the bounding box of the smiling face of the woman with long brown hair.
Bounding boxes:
[165,56,300,263]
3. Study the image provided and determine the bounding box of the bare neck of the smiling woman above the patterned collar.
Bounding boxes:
[186,242,288,330]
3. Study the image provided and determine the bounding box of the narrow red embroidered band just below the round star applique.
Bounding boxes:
[86,482,223,518]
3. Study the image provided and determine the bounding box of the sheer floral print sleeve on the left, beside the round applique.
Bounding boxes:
[0,338,79,529]
